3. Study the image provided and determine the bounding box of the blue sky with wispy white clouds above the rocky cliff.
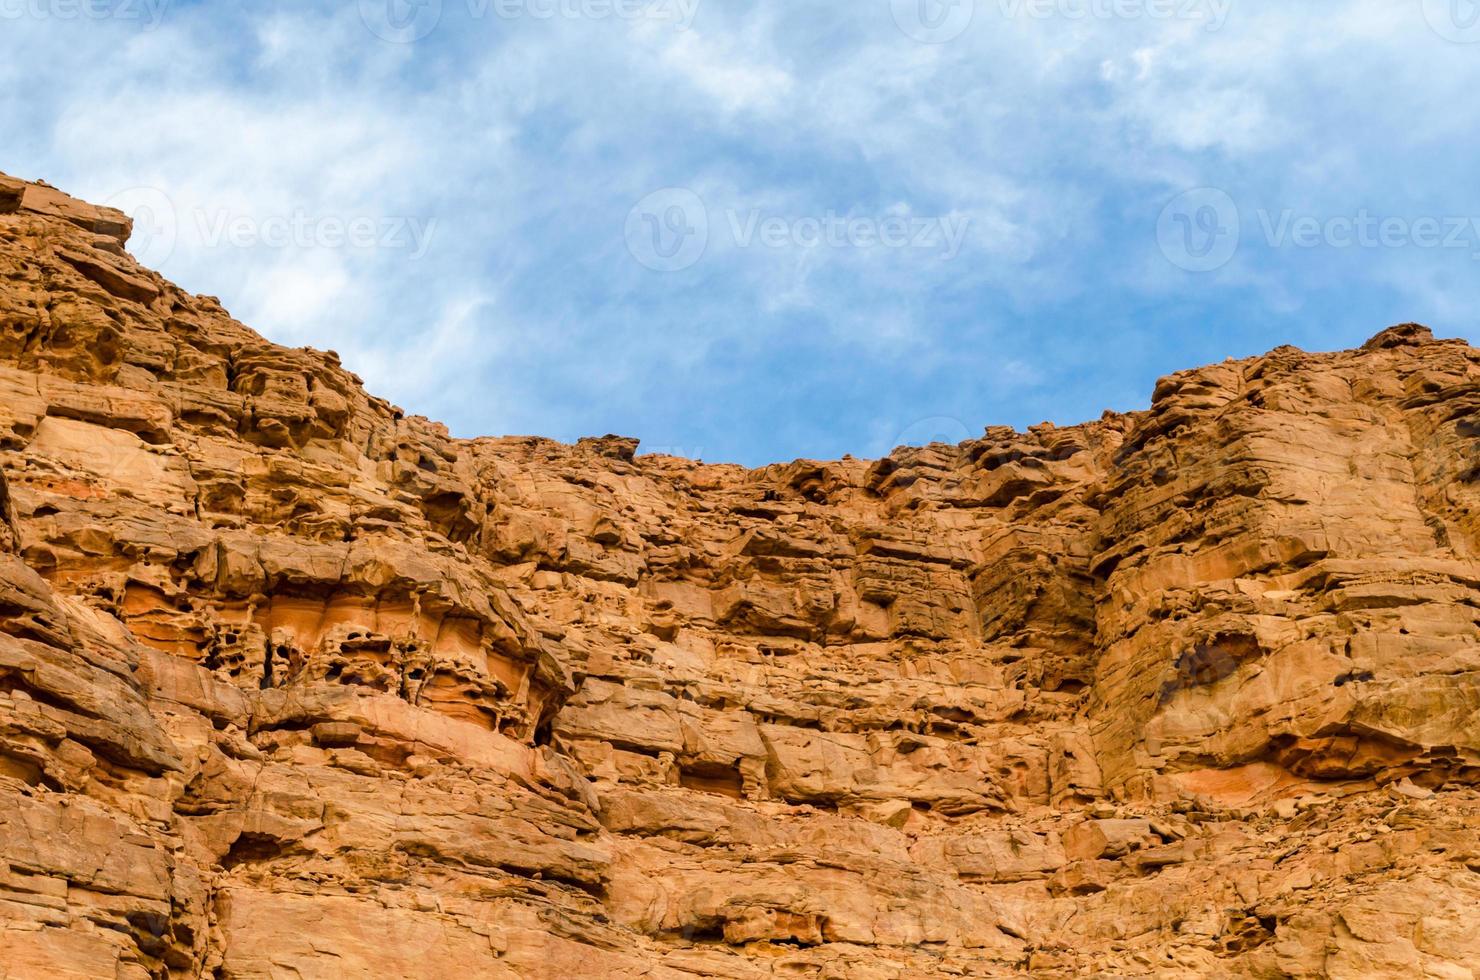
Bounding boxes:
[0,0,1480,465]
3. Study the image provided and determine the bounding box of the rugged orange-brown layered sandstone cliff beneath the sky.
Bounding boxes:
[0,178,1480,980]
